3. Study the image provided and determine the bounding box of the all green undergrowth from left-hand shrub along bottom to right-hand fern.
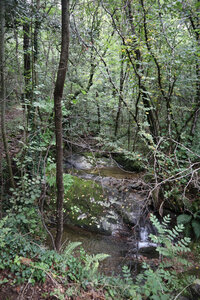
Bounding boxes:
[0,177,199,300]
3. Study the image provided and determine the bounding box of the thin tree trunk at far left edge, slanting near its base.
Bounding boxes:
[0,0,15,188]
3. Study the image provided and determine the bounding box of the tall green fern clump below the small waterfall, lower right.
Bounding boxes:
[137,215,194,300]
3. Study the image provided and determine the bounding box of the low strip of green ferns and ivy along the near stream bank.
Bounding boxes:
[0,205,198,300]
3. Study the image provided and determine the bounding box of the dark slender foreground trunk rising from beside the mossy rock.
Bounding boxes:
[54,0,69,251]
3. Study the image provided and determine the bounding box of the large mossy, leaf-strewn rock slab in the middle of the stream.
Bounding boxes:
[64,153,148,239]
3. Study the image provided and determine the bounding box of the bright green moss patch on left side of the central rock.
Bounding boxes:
[64,176,107,227]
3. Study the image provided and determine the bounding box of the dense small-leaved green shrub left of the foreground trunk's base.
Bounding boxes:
[0,175,45,281]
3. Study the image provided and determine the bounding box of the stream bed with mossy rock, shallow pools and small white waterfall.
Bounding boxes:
[63,154,156,275]
